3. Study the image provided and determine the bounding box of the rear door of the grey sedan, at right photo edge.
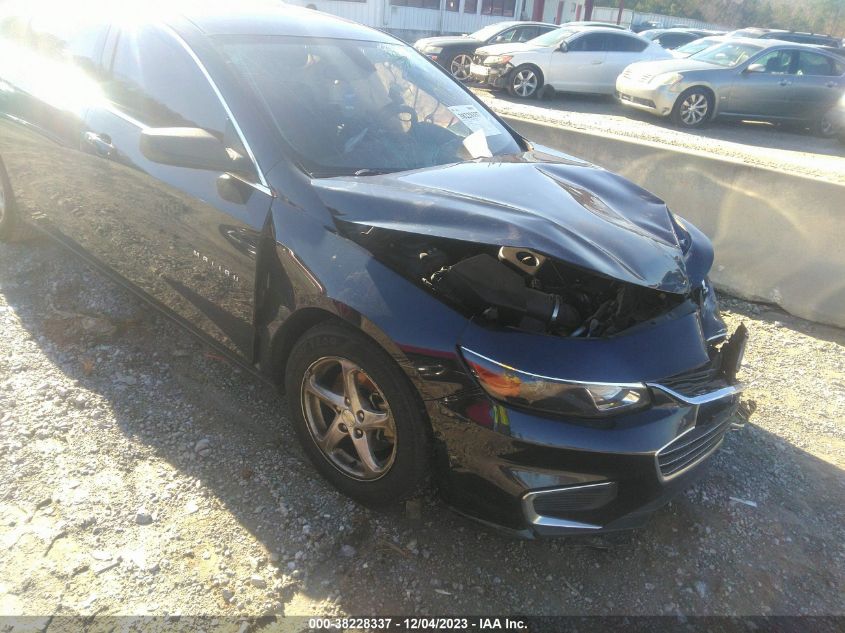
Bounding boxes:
[794,50,845,121]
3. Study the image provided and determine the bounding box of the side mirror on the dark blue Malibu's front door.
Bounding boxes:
[141,127,238,172]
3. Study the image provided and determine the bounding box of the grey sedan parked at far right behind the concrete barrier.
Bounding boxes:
[616,39,845,132]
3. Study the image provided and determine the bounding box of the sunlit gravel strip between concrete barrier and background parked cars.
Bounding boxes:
[473,88,845,183]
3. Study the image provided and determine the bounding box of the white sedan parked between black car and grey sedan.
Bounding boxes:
[470,26,672,99]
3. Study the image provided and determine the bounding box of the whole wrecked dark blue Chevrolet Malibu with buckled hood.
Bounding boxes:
[0,1,746,536]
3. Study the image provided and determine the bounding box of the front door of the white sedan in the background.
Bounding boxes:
[549,32,607,92]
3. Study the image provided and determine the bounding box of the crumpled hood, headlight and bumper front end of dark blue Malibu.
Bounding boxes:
[315,152,746,534]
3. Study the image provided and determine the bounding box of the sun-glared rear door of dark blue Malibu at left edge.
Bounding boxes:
[0,5,108,238]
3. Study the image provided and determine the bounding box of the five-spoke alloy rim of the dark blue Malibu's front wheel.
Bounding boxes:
[300,356,396,480]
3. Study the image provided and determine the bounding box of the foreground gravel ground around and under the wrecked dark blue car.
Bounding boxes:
[0,237,845,617]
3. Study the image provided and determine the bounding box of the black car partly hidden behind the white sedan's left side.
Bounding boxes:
[414,22,559,81]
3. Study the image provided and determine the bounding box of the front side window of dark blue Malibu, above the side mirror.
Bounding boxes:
[108,26,227,138]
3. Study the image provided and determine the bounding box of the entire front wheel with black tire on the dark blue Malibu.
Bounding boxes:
[285,322,429,506]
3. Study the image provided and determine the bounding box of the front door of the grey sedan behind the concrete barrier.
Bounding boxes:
[720,48,798,119]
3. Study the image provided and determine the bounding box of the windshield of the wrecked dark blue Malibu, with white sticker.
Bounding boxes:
[216,36,521,177]
